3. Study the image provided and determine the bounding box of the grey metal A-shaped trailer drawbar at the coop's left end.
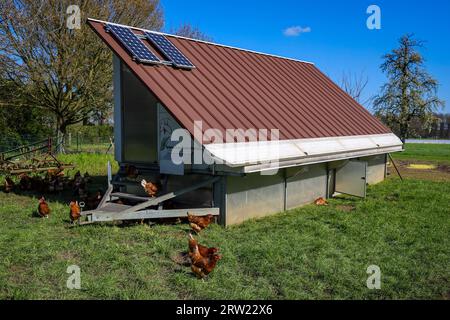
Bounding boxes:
[79,162,221,225]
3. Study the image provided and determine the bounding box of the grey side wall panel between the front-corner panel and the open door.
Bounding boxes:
[286,164,327,209]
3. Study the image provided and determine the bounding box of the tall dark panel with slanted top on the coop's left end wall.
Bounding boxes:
[122,64,158,164]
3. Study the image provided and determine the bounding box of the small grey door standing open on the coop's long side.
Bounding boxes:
[335,160,367,198]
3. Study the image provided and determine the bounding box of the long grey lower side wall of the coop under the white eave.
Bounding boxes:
[224,154,386,225]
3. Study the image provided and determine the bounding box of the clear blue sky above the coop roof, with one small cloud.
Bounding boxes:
[161,0,450,112]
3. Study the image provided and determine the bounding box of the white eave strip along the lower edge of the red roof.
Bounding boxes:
[205,133,403,172]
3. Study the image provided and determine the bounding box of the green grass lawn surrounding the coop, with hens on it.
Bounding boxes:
[0,146,450,299]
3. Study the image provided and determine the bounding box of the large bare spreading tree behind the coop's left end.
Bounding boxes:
[0,0,163,151]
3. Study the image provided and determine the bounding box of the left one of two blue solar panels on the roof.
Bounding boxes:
[107,24,161,63]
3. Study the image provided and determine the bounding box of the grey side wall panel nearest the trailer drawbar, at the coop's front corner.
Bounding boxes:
[226,172,284,225]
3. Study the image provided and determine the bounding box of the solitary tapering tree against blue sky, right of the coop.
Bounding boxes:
[374,35,445,141]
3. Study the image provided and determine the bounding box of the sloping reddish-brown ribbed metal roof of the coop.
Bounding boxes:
[88,20,391,144]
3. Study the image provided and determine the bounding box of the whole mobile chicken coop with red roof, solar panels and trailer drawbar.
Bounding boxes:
[85,19,403,225]
